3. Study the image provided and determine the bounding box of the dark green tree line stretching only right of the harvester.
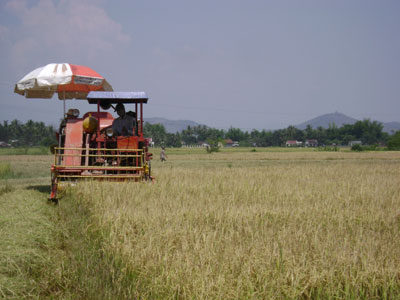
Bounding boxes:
[144,119,390,147]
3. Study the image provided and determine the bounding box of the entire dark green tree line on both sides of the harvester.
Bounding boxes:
[0,119,399,147]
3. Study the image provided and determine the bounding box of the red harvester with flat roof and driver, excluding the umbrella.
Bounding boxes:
[50,92,153,202]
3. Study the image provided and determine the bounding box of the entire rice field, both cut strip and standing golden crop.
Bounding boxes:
[0,148,400,299]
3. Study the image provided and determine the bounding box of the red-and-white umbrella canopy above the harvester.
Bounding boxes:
[14,63,113,100]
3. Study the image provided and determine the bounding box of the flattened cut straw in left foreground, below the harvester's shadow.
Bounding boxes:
[0,186,59,299]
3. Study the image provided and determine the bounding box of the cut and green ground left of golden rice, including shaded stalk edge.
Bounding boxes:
[0,155,150,300]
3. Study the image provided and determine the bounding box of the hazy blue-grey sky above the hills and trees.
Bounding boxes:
[0,0,400,130]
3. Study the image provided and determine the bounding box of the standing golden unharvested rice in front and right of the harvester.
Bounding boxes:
[69,149,400,299]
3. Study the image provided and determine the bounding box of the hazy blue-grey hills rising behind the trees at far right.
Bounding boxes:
[295,112,400,133]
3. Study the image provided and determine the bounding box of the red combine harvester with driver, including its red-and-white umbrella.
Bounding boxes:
[14,63,153,202]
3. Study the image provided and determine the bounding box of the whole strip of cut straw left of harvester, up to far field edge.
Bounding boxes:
[0,155,60,299]
